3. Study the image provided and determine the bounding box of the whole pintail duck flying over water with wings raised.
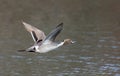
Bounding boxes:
[19,22,75,53]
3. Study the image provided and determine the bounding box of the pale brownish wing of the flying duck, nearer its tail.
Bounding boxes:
[22,22,46,42]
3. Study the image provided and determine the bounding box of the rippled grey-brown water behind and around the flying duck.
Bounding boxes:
[0,0,120,76]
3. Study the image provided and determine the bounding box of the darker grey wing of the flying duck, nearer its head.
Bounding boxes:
[45,23,63,41]
